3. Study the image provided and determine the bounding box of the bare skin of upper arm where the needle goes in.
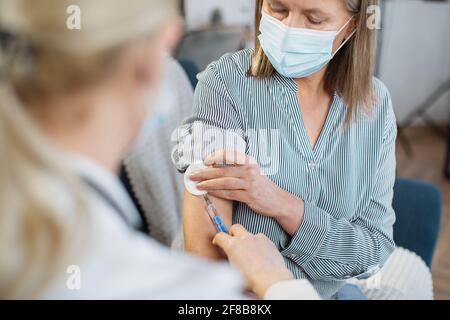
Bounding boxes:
[183,190,233,259]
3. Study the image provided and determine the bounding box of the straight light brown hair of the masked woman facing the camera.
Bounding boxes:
[249,0,379,125]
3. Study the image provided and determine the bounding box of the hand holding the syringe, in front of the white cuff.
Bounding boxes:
[213,225,294,299]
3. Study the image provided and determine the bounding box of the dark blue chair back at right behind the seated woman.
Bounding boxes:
[393,178,441,267]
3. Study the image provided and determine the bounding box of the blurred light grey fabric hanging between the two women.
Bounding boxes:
[124,58,193,246]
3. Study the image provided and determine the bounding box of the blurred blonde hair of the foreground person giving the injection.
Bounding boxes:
[0,0,176,299]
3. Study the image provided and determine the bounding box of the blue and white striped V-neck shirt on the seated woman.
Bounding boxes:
[173,49,397,298]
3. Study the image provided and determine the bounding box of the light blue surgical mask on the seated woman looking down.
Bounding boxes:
[258,10,356,78]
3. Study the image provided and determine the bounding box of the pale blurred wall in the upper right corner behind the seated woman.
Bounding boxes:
[379,0,450,124]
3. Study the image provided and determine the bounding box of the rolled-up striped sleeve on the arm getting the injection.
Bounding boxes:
[172,62,246,172]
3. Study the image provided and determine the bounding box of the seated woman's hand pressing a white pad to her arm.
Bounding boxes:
[190,151,304,235]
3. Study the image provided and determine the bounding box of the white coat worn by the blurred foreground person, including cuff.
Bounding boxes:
[41,157,318,299]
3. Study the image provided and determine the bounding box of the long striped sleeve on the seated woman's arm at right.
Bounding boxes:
[282,89,397,280]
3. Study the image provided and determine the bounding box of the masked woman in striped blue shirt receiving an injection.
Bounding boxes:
[174,0,396,298]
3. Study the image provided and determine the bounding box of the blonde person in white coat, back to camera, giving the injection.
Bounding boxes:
[0,0,316,299]
